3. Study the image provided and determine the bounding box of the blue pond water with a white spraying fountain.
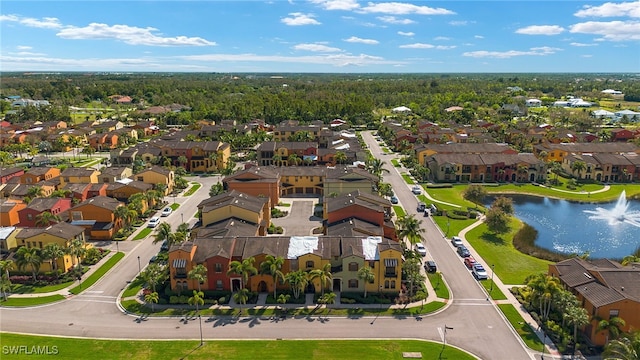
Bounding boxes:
[488,195,640,258]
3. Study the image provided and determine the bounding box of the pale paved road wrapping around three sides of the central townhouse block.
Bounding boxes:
[0,153,532,360]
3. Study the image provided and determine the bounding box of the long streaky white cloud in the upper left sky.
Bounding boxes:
[56,23,216,46]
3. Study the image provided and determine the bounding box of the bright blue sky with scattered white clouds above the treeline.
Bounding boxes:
[0,0,640,73]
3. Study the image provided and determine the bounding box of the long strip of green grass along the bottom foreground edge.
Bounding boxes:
[2,334,475,360]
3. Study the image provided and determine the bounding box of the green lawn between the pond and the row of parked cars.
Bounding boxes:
[466,218,551,285]
